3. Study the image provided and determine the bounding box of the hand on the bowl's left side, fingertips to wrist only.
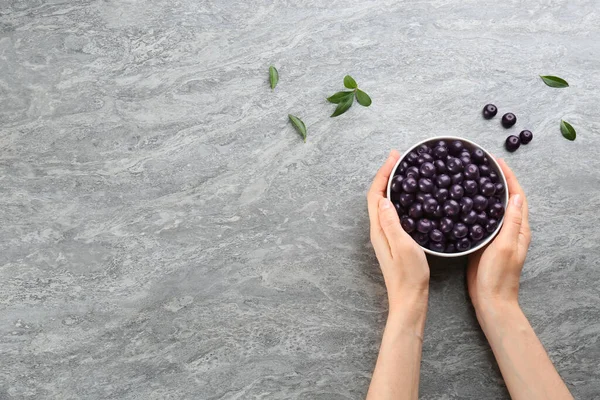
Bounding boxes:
[367,150,429,313]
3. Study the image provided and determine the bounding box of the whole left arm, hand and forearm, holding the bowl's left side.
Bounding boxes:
[367,150,429,400]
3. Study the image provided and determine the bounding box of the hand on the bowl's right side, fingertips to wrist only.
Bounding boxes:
[467,159,531,312]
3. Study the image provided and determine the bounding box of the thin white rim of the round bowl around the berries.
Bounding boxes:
[387,136,508,257]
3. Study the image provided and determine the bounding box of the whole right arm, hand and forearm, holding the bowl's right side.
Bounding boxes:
[467,160,573,400]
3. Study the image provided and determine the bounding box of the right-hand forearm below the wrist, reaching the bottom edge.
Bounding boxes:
[477,302,573,400]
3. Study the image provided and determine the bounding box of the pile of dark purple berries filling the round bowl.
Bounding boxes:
[390,140,506,253]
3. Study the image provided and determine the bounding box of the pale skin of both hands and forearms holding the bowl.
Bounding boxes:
[367,150,573,400]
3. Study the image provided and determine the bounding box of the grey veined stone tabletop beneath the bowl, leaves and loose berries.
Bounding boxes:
[0,0,600,400]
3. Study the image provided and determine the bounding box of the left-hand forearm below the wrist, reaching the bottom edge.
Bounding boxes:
[367,293,427,400]
